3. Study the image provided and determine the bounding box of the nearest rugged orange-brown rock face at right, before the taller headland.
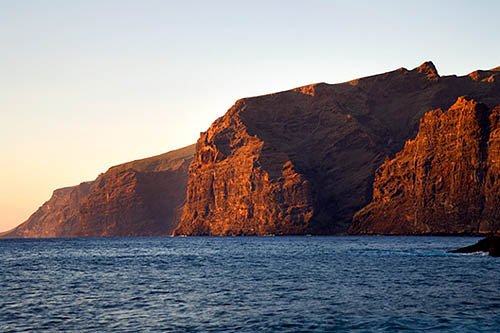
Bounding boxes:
[351,97,500,234]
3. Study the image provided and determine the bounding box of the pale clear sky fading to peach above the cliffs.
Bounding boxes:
[0,0,500,231]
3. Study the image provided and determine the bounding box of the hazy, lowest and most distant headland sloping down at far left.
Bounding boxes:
[2,145,194,238]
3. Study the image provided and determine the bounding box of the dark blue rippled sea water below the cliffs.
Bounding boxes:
[0,237,500,332]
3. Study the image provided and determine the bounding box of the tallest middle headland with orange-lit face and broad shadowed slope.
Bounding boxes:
[175,63,500,235]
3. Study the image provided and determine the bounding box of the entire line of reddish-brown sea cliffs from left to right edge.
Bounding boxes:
[4,62,500,237]
